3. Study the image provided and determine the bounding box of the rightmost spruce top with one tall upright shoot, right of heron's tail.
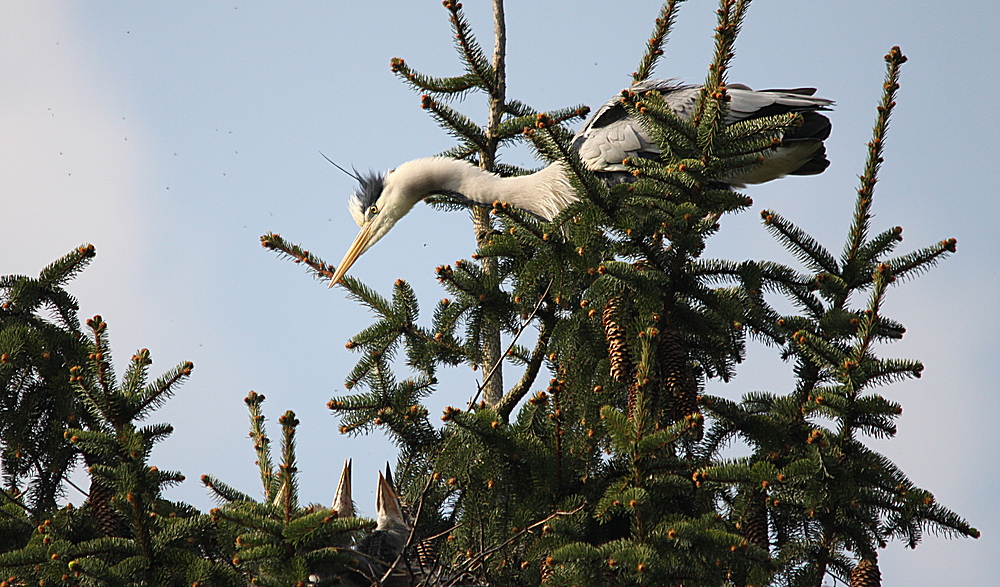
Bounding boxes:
[700,47,979,585]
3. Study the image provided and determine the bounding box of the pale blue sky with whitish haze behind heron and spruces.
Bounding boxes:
[0,0,1000,586]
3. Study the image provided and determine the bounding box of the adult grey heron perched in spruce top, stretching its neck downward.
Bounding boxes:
[330,80,833,287]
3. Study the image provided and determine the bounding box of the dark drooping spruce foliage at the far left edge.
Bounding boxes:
[0,245,94,516]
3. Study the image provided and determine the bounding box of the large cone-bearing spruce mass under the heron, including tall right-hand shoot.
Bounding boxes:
[262,0,978,587]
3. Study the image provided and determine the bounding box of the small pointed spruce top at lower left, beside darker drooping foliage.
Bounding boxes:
[0,304,240,586]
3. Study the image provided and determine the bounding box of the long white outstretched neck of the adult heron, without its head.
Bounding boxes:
[387,157,576,220]
